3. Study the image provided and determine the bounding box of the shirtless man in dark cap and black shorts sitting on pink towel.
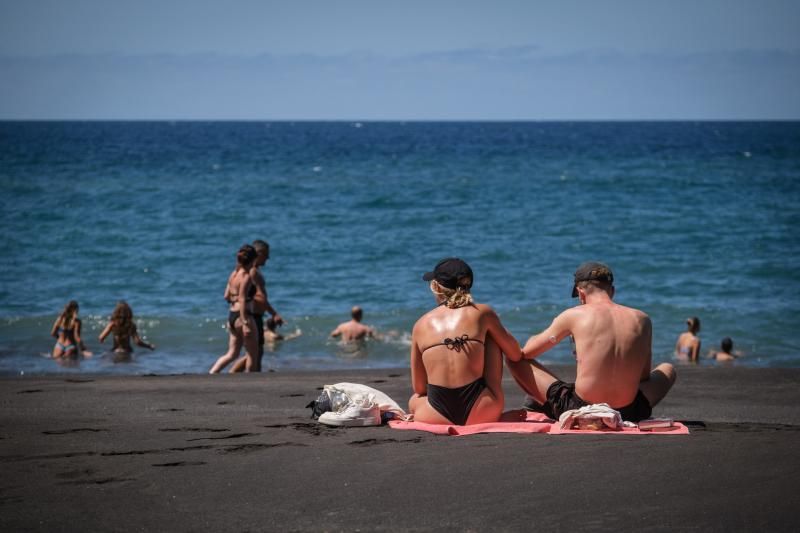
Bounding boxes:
[506,262,675,422]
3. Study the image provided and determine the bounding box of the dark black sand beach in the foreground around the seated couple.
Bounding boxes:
[0,368,800,531]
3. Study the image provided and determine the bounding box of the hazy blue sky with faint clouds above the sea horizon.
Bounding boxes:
[0,0,800,120]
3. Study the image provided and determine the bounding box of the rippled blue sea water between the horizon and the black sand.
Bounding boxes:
[0,122,800,375]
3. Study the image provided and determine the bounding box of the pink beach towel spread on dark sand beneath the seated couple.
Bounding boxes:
[389,409,689,436]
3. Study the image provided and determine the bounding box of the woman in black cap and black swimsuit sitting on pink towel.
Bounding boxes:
[408,258,522,425]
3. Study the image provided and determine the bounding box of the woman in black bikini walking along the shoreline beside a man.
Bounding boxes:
[210,244,258,374]
